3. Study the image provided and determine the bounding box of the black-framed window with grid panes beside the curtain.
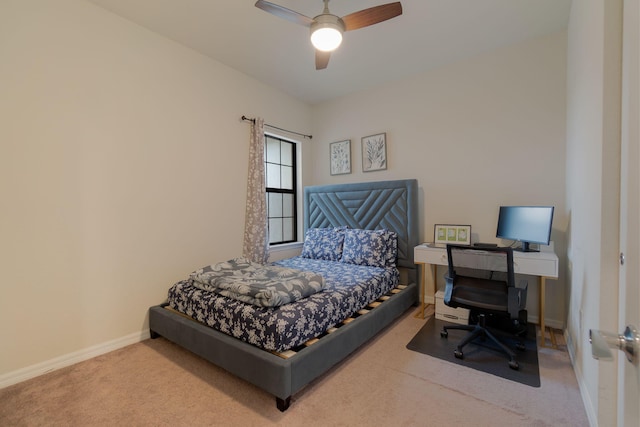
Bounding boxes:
[264,135,298,245]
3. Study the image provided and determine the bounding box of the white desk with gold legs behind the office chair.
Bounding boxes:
[413,244,558,348]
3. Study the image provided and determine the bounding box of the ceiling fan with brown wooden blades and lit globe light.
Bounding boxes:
[256,0,402,70]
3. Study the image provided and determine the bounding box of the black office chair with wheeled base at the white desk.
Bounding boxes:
[440,245,528,370]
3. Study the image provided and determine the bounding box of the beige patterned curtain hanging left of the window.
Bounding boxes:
[243,117,269,264]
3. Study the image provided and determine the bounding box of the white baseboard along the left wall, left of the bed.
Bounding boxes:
[0,330,149,388]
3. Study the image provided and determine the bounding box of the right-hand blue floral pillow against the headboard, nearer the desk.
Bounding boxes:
[342,230,389,268]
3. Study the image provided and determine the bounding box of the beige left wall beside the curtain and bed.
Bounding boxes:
[0,0,311,378]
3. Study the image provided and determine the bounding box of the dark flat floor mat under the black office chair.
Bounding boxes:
[407,318,540,387]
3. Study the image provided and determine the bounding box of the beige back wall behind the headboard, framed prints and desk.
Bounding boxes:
[313,32,567,327]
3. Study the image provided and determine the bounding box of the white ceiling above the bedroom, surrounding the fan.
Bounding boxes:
[88,0,571,104]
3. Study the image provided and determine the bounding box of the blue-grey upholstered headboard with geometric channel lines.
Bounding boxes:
[304,179,418,269]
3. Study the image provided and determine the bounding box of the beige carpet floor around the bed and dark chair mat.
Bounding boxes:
[0,310,589,427]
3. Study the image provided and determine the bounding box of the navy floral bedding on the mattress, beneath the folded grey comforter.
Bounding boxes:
[168,257,399,352]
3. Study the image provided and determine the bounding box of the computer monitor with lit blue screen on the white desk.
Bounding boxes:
[496,206,553,252]
